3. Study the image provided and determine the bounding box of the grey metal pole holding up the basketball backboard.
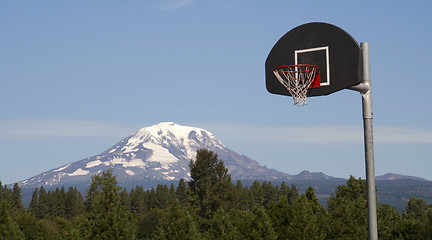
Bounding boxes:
[361,42,378,240]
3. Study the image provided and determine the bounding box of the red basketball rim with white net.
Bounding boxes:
[273,64,321,106]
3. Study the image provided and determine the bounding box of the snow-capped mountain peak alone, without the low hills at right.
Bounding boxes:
[19,122,292,188]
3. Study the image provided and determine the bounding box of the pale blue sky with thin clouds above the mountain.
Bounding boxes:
[0,0,432,183]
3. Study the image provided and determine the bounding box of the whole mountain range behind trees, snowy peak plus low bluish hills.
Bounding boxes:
[9,122,432,209]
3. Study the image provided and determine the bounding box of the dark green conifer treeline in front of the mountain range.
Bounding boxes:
[0,150,432,240]
